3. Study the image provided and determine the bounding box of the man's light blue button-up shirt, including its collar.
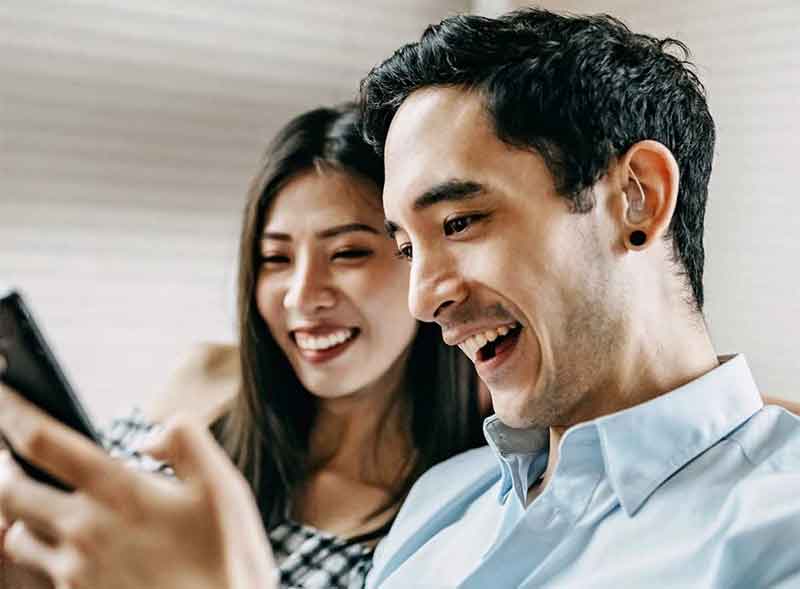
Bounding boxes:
[368,356,800,589]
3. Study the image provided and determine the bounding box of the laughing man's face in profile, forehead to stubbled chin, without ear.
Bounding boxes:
[384,88,621,427]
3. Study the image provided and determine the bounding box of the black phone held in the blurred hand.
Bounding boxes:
[0,290,102,491]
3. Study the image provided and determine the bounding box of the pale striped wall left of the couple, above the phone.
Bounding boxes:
[0,0,468,421]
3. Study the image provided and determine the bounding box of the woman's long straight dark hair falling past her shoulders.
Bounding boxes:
[214,104,482,528]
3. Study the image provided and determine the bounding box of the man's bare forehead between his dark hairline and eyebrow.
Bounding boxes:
[384,87,496,219]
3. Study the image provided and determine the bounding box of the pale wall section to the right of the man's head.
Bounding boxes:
[515,0,800,400]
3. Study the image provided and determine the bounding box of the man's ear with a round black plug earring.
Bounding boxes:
[618,139,680,251]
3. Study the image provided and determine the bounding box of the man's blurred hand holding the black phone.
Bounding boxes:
[0,385,276,589]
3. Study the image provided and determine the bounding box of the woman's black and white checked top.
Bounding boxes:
[103,410,378,589]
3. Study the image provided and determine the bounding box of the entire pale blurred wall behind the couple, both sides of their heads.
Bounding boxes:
[0,0,800,422]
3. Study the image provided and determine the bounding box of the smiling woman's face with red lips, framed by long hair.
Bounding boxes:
[256,169,416,398]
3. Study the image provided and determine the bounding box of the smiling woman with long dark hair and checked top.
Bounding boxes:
[0,105,482,588]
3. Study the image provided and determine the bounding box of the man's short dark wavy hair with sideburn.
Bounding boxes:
[361,9,715,311]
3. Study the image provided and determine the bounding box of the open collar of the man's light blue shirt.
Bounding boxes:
[483,355,763,515]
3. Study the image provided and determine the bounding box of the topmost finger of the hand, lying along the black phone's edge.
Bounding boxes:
[0,383,130,502]
